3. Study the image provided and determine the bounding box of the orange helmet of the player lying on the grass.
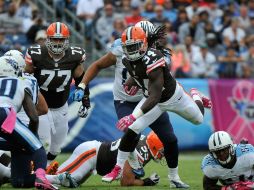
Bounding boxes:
[146,131,164,161]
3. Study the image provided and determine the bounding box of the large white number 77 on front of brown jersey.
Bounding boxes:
[41,70,71,92]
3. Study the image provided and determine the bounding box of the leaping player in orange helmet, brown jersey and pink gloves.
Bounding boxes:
[99,26,210,182]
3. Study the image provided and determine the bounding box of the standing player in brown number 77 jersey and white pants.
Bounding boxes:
[25,22,90,163]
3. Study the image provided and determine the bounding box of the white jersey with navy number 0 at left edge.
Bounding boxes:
[0,77,37,112]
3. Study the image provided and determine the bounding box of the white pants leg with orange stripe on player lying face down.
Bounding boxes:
[47,141,101,187]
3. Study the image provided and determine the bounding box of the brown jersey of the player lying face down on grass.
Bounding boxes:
[96,136,152,176]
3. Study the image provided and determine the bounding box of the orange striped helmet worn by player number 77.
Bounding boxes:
[45,22,70,54]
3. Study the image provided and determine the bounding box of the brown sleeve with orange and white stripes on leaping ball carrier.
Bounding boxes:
[144,50,167,75]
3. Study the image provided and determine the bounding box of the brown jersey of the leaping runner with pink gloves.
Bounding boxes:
[122,48,176,102]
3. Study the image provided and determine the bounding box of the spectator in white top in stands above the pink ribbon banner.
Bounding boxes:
[222,18,245,43]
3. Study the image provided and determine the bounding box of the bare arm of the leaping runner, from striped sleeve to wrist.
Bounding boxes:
[138,67,164,114]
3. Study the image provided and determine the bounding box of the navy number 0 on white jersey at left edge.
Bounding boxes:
[0,79,17,99]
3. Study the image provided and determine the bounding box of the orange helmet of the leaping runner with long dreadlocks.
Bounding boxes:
[122,26,148,61]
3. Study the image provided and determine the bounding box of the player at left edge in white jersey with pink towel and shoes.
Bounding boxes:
[0,56,56,190]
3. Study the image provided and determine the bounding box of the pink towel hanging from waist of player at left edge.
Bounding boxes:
[2,108,17,134]
